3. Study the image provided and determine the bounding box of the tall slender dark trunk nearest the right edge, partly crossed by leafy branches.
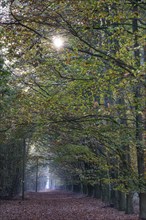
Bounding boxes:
[132,0,146,220]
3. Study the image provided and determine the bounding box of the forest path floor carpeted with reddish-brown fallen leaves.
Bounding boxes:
[0,191,138,220]
